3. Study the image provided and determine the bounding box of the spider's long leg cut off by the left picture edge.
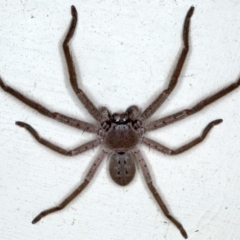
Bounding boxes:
[0,78,98,133]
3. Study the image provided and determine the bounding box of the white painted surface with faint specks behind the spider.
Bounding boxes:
[0,0,240,240]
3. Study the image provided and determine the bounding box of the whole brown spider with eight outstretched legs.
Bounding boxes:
[0,6,240,238]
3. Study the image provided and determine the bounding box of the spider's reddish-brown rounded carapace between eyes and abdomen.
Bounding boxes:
[104,124,138,152]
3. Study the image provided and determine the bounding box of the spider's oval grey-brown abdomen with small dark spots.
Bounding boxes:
[109,152,136,186]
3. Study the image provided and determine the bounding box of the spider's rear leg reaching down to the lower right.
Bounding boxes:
[132,148,188,238]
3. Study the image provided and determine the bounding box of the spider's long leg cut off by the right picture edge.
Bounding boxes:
[145,78,240,131]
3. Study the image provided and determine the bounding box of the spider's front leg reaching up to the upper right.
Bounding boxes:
[140,7,194,122]
